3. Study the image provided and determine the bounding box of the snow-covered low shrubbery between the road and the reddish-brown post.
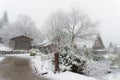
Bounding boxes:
[31,55,54,74]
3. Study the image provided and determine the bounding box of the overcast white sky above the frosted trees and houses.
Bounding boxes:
[0,0,120,45]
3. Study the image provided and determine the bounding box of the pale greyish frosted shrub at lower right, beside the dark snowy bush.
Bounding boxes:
[84,60,110,77]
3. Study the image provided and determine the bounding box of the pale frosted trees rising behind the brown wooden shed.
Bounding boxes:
[1,15,43,44]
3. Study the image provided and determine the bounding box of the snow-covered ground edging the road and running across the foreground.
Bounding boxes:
[0,54,120,80]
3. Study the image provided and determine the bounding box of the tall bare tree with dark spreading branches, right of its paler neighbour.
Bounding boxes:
[65,7,98,45]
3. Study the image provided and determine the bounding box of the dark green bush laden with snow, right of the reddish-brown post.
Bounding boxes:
[59,47,86,74]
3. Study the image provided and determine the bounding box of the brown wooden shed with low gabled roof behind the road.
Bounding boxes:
[10,35,33,50]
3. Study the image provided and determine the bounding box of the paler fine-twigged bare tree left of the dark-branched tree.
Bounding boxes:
[44,11,67,48]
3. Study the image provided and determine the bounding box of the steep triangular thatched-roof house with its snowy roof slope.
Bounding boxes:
[77,34,107,54]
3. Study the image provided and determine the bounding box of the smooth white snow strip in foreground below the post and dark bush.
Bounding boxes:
[46,71,97,80]
